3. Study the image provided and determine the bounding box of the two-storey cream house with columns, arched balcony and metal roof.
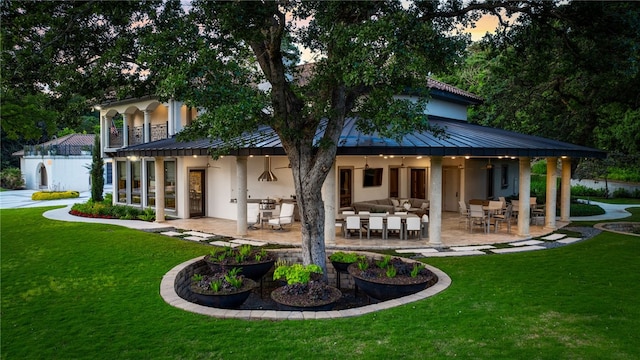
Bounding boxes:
[100,80,605,245]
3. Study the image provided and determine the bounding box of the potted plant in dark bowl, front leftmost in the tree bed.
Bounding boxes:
[190,268,258,309]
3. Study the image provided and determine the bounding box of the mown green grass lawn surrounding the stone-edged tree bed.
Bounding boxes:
[0,208,640,359]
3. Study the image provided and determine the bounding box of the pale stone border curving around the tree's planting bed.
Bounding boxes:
[160,252,451,320]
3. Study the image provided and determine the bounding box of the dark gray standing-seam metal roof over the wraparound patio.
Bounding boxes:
[117,116,606,158]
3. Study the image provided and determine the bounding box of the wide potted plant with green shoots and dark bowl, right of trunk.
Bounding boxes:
[347,255,438,300]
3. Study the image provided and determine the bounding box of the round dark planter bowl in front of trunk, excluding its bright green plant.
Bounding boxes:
[271,281,342,311]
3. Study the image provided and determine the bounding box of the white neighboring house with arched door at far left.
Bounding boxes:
[12,134,101,191]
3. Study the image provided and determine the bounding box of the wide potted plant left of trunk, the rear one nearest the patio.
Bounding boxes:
[204,245,275,281]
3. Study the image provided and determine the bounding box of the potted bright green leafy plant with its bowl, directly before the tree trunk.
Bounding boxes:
[271,264,342,311]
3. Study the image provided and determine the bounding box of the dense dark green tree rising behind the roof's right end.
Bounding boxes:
[447,1,640,154]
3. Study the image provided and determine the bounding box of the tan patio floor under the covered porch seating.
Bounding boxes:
[166,212,567,249]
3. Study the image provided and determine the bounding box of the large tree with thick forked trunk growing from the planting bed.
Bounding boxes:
[142,1,528,267]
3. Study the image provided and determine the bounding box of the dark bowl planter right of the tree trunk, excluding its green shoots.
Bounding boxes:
[348,264,437,301]
